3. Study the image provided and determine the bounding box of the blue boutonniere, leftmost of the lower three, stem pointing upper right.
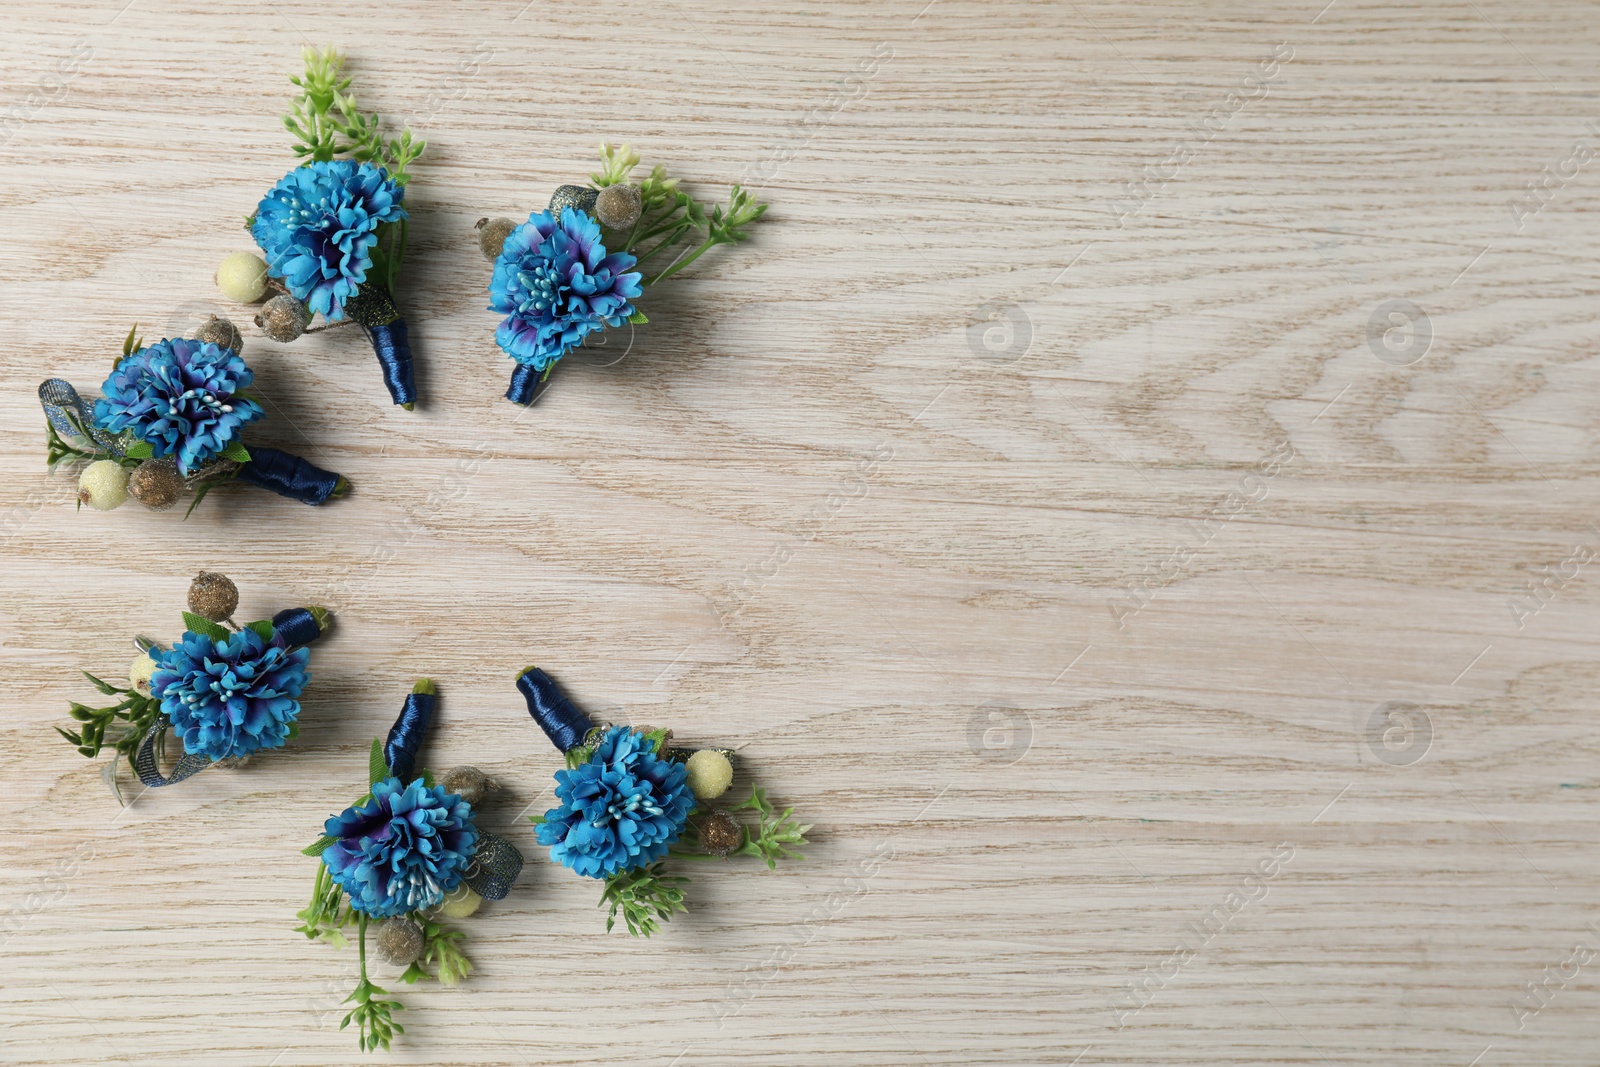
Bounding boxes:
[56,571,330,800]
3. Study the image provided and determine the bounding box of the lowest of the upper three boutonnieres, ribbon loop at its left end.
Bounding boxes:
[38,323,350,518]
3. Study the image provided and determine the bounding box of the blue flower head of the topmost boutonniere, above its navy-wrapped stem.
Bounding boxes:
[250,160,408,322]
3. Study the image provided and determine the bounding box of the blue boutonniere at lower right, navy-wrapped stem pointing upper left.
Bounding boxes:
[517,667,811,937]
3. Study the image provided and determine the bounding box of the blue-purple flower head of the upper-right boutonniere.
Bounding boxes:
[490,208,643,371]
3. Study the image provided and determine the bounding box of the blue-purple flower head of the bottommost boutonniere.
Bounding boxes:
[322,777,478,918]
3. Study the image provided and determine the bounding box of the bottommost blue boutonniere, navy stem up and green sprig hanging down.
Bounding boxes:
[298,678,522,1053]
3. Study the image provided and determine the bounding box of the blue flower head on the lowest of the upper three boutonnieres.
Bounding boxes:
[94,338,262,475]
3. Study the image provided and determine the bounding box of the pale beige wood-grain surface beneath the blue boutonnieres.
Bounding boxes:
[0,0,1600,1067]
